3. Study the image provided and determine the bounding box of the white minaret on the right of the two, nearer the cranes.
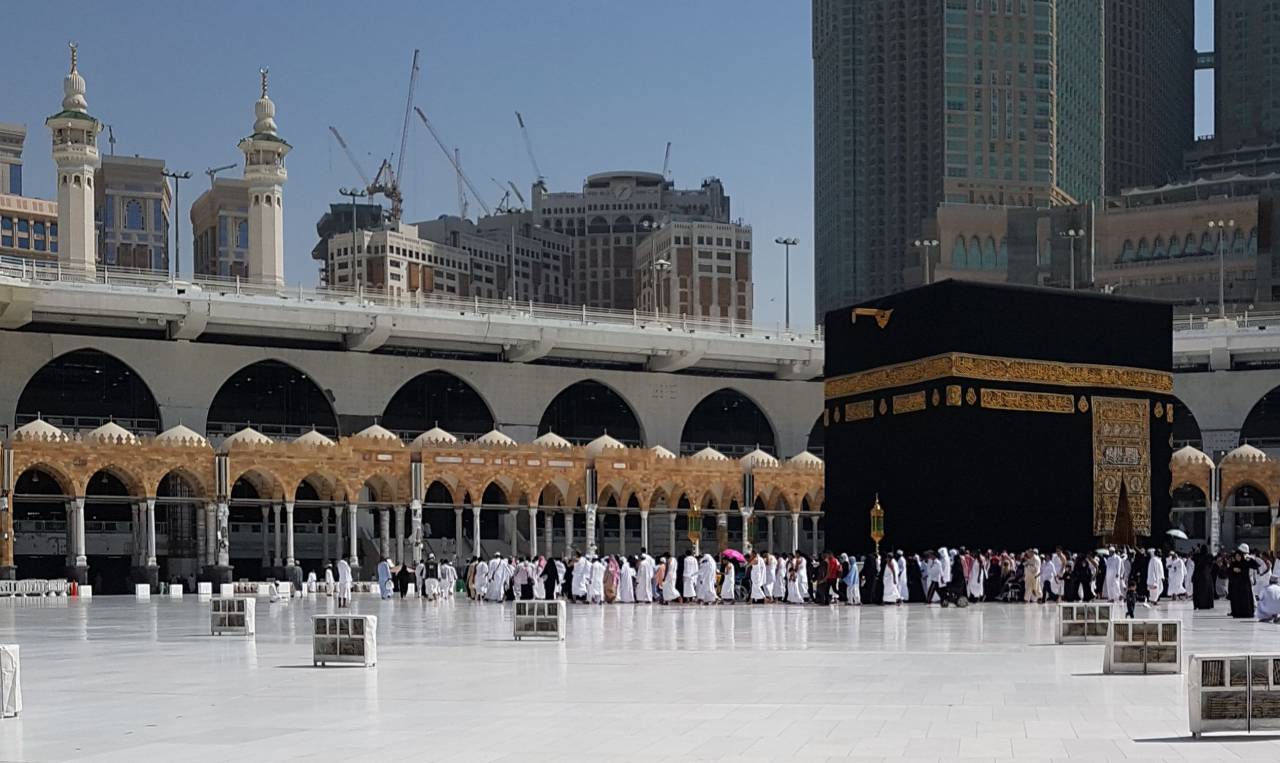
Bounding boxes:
[238,69,292,285]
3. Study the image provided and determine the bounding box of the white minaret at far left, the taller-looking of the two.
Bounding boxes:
[45,42,102,273]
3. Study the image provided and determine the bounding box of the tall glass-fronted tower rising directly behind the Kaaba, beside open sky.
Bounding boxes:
[813,0,1105,315]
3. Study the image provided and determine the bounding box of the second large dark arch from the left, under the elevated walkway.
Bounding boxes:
[207,360,338,439]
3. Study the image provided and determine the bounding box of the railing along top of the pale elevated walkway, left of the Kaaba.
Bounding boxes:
[0,256,822,344]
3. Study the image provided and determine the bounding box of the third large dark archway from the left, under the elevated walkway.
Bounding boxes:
[380,371,494,439]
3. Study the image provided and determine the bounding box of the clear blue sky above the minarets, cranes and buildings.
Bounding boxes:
[0,0,1212,325]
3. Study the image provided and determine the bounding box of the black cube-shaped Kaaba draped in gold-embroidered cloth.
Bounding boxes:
[823,280,1174,552]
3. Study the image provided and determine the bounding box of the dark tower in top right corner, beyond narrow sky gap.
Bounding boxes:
[1213,0,1280,151]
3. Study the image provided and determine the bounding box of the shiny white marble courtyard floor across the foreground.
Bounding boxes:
[0,597,1280,763]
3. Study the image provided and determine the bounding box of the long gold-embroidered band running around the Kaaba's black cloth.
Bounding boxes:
[824,352,1174,399]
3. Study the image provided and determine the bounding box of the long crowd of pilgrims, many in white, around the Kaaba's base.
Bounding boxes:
[366,544,1280,620]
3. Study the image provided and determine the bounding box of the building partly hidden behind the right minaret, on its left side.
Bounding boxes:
[191,178,250,279]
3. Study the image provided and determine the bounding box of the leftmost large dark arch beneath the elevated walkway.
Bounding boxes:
[15,347,160,433]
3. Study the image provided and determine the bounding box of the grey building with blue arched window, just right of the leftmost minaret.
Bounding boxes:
[93,156,170,271]
